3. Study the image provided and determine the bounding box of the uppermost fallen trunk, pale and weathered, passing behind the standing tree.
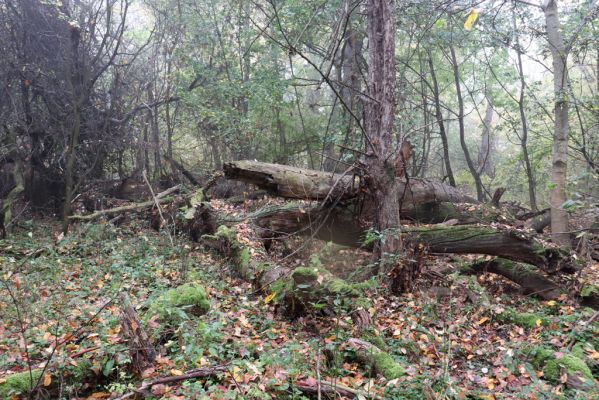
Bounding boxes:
[223,160,478,209]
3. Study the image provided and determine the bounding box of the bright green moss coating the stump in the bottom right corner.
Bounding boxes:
[533,348,593,382]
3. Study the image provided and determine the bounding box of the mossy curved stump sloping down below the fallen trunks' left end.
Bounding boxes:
[202,225,254,280]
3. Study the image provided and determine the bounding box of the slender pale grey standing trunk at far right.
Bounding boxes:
[543,0,570,246]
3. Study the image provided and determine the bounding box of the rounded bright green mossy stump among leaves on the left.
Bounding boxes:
[147,283,210,333]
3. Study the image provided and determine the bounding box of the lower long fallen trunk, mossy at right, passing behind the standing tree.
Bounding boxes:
[253,206,577,272]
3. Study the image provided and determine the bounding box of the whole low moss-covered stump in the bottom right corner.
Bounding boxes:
[531,347,596,389]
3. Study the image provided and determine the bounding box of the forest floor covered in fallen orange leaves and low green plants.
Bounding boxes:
[0,201,599,399]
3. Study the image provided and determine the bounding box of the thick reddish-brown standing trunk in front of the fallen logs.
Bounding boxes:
[365,0,409,290]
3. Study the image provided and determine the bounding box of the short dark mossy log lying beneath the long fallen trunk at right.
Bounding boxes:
[463,258,564,300]
